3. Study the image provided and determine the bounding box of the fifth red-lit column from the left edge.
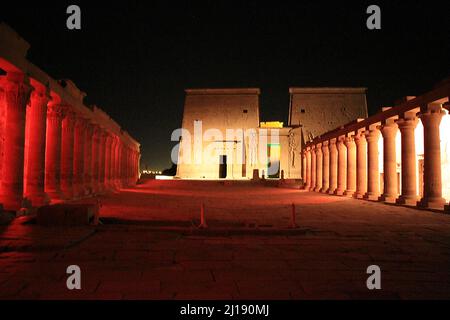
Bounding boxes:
[73,117,87,198]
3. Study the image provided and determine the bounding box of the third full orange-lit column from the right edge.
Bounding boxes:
[380,119,398,203]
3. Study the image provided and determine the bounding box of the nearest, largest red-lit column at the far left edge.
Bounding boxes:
[0,73,32,210]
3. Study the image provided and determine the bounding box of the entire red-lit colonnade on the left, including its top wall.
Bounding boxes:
[0,24,140,211]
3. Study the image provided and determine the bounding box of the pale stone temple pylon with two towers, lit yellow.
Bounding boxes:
[177,88,367,180]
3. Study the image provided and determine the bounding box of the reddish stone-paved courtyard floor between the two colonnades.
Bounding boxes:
[0,181,450,299]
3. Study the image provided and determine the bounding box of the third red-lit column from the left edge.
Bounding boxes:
[45,101,64,200]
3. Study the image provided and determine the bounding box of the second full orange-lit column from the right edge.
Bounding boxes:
[397,113,419,206]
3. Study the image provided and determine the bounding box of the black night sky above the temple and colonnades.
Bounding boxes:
[0,0,450,169]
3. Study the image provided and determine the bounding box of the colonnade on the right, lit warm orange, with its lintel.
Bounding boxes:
[302,82,450,210]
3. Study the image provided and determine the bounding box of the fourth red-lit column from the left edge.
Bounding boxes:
[61,110,76,199]
